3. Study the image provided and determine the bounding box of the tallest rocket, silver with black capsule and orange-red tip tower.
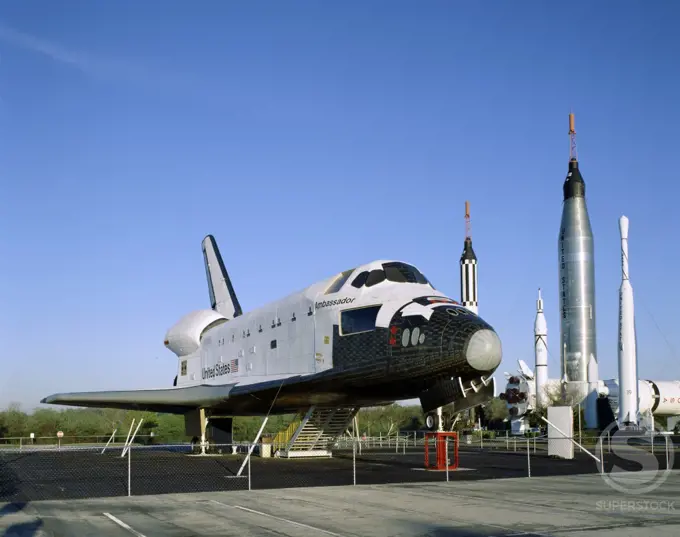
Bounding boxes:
[558,114,598,429]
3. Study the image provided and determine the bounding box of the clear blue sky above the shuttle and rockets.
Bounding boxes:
[0,0,680,408]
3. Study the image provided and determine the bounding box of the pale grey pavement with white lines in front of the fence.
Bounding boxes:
[0,472,680,537]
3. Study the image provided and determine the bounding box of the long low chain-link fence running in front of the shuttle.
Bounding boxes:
[0,435,680,502]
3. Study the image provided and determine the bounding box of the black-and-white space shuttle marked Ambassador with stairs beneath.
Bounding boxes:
[41,235,502,457]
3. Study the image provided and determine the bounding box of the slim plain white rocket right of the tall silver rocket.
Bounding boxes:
[619,216,638,425]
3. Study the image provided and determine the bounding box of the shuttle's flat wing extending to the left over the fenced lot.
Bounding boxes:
[40,384,234,414]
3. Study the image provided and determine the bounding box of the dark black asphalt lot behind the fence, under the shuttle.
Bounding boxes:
[0,447,680,503]
